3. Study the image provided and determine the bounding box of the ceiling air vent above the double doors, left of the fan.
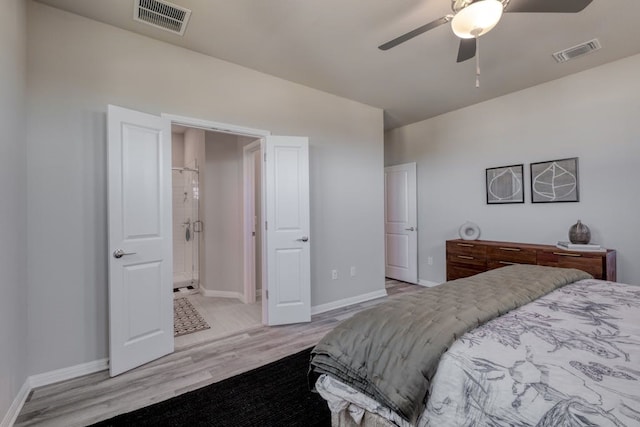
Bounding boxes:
[133,0,191,35]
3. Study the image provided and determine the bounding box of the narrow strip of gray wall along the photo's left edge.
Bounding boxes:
[0,0,27,423]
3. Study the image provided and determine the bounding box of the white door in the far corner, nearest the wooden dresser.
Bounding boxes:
[384,163,418,283]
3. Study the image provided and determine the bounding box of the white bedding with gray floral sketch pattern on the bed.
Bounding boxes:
[320,279,640,427]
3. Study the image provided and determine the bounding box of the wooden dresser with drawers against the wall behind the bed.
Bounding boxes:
[447,239,616,282]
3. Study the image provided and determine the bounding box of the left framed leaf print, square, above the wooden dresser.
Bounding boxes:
[485,163,524,205]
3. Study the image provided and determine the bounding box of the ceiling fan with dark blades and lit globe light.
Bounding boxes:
[378,0,593,62]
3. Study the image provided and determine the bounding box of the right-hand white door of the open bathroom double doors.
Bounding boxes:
[263,136,311,325]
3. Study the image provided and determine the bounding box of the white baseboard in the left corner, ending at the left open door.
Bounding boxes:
[0,359,109,427]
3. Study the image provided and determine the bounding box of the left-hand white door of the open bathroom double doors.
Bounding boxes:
[108,105,173,376]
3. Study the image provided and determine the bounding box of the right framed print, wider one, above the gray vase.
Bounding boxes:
[530,157,580,203]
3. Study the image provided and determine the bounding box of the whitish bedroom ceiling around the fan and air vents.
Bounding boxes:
[39,0,640,129]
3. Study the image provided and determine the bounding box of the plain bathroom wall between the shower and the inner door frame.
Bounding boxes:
[202,132,244,294]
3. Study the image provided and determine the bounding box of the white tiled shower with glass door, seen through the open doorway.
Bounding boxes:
[171,165,202,289]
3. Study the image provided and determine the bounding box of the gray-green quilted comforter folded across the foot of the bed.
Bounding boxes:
[311,265,591,422]
